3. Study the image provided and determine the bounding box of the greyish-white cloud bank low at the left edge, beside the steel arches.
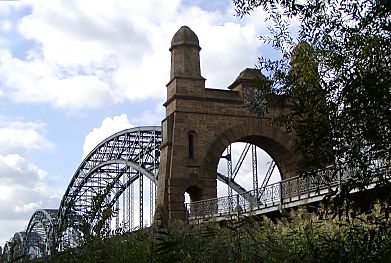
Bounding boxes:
[0,116,62,244]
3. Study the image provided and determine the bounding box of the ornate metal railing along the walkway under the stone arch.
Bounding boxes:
[185,164,390,220]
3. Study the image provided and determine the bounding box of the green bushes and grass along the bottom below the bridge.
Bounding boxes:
[31,204,391,263]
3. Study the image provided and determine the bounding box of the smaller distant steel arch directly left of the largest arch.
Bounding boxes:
[25,209,58,257]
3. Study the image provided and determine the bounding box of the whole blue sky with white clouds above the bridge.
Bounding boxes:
[0,0,282,246]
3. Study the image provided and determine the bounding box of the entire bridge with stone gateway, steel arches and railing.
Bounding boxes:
[3,26,390,262]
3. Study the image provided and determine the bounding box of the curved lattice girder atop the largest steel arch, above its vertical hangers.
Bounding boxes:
[58,126,161,249]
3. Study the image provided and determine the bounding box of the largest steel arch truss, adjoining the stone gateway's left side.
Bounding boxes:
[58,126,161,249]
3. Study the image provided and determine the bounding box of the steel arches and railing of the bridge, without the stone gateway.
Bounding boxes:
[4,126,390,262]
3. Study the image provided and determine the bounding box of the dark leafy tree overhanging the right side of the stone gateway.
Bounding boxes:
[233,0,391,198]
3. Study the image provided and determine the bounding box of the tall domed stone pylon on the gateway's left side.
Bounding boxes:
[158,26,211,223]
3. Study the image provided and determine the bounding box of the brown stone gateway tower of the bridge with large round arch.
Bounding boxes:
[157,26,300,221]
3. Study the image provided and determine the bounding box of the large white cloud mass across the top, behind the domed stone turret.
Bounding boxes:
[0,0,270,113]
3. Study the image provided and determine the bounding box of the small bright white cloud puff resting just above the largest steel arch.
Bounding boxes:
[83,114,133,158]
